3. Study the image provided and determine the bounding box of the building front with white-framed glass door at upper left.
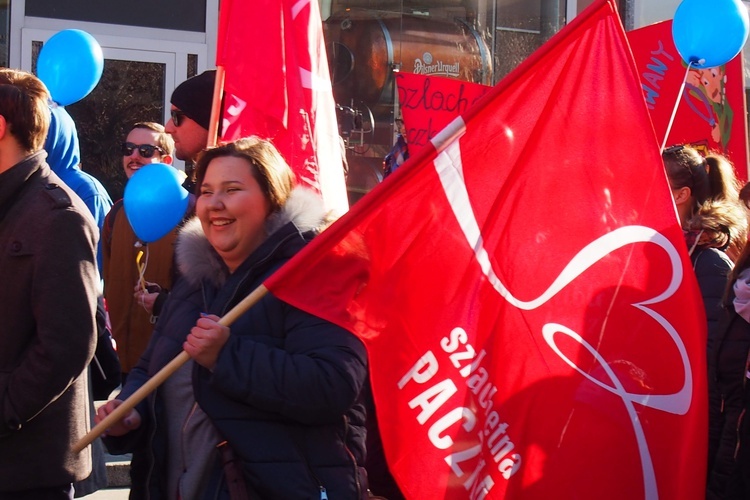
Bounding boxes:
[0,0,219,198]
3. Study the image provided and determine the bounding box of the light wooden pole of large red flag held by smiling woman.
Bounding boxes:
[73,285,268,453]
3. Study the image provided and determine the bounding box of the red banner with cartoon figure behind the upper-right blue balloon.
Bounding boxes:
[628,20,748,180]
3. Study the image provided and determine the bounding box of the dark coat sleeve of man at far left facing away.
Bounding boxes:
[0,201,97,428]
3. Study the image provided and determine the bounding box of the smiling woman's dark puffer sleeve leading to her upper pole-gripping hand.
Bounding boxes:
[204,295,367,424]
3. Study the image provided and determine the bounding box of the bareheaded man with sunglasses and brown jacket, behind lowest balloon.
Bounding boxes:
[102,122,177,382]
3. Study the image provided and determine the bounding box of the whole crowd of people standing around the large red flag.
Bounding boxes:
[0,63,750,500]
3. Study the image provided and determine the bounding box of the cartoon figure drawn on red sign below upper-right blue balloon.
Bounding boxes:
[683,65,734,149]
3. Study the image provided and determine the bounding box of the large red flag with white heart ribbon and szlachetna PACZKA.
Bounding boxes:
[266,0,707,500]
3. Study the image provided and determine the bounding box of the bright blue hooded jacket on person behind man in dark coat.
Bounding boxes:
[44,104,112,275]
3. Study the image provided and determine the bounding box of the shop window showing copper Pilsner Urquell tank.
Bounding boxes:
[321,0,566,201]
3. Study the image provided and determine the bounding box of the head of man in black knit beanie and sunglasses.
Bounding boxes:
[165,70,221,191]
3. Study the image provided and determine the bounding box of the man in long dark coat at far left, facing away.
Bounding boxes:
[0,68,97,500]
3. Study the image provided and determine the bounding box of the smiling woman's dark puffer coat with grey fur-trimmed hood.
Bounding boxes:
[107,191,367,500]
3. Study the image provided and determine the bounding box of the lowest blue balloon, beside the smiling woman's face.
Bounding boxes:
[122,163,189,243]
